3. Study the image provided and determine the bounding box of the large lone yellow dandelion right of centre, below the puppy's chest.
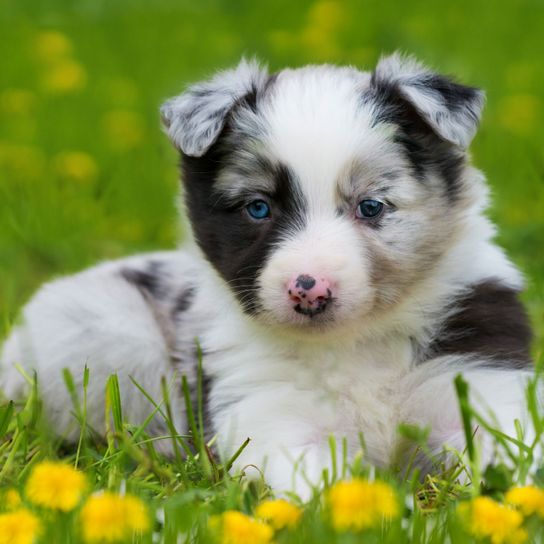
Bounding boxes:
[327,480,399,531]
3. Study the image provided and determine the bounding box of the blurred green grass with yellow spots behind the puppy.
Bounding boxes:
[0,0,544,353]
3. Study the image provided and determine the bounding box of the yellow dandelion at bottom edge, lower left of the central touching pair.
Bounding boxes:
[210,510,274,544]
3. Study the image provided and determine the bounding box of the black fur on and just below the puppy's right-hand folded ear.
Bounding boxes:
[362,74,477,200]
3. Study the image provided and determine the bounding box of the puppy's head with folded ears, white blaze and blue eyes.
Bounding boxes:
[161,55,483,330]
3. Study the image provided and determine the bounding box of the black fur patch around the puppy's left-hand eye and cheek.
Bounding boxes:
[182,140,304,314]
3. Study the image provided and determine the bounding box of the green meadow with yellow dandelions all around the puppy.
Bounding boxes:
[0,0,544,544]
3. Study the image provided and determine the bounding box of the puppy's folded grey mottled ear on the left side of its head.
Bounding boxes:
[161,59,267,157]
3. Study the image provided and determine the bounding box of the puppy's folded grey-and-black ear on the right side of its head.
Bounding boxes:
[371,53,485,149]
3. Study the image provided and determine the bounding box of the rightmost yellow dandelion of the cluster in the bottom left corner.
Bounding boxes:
[81,492,150,542]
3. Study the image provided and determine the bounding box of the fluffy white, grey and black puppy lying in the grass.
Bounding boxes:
[1,55,531,493]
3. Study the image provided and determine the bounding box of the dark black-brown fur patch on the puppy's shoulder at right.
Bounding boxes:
[430,281,532,368]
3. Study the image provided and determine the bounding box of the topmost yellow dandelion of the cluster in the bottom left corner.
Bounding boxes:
[25,461,87,512]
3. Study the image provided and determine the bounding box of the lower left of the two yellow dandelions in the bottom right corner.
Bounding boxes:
[458,497,527,544]
